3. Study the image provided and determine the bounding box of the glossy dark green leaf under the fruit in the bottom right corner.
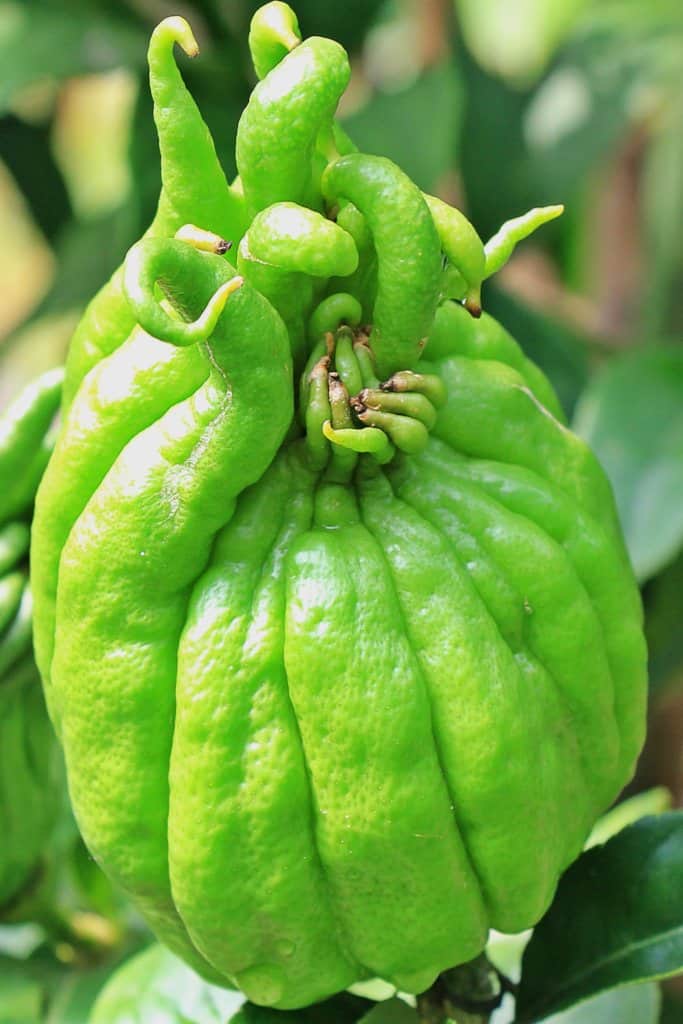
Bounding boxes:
[516,811,683,1024]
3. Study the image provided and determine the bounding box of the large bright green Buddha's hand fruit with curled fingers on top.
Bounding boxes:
[28,4,645,1008]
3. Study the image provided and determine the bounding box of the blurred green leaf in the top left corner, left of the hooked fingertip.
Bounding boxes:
[0,0,147,112]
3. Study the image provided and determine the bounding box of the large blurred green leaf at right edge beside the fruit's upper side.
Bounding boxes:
[574,348,683,581]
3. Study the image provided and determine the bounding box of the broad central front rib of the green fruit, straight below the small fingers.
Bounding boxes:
[288,491,485,984]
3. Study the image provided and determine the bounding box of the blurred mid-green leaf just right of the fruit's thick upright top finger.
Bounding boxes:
[344,59,463,191]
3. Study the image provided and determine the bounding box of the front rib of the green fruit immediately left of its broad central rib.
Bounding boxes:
[171,456,361,1009]
